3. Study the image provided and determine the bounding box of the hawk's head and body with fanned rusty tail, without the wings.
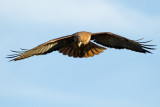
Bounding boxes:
[59,31,106,58]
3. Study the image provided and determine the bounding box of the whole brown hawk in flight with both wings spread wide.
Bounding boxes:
[8,31,155,61]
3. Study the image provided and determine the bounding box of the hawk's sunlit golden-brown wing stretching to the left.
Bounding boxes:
[7,35,74,61]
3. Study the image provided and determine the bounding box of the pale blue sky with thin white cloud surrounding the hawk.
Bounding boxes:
[0,0,160,107]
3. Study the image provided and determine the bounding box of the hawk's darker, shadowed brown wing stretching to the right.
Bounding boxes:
[91,32,155,53]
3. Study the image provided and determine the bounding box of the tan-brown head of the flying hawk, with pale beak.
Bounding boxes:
[74,32,91,47]
